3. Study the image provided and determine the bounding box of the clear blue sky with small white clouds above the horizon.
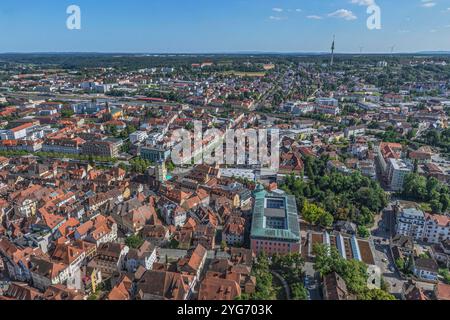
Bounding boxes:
[0,0,450,53]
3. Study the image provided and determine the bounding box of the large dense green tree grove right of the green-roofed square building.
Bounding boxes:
[280,157,387,226]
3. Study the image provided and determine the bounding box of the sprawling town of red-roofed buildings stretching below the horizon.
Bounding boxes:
[0,55,450,301]
